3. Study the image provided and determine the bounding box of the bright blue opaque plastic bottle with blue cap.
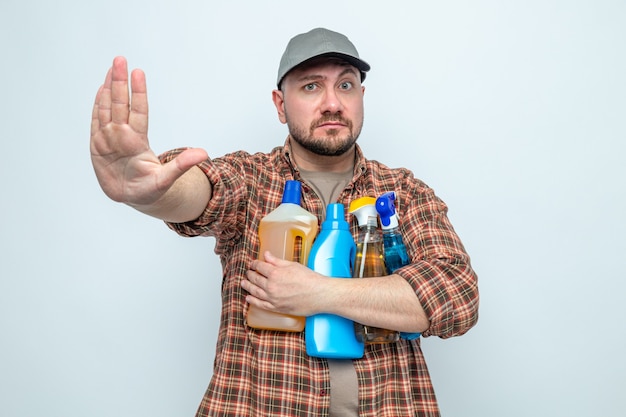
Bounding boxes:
[304,203,365,359]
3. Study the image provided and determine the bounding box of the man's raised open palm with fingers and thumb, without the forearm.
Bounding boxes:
[90,57,207,205]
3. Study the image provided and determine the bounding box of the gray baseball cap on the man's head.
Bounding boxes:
[276,28,370,88]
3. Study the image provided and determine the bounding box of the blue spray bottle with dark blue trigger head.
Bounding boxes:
[376,191,420,340]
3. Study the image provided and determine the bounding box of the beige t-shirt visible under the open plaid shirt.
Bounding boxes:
[300,169,359,417]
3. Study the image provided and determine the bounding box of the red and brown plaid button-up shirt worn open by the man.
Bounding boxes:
[162,140,478,417]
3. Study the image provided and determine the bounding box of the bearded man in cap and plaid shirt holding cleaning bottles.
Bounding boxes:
[91,29,478,417]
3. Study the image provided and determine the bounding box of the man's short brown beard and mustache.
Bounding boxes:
[285,114,363,156]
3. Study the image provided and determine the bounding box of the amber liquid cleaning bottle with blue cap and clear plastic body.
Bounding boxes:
[246,180,318,332]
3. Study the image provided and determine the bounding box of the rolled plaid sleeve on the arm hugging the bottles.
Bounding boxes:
[395,182,479,338]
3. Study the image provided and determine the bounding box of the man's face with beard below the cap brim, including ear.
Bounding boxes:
[274,59,365,156]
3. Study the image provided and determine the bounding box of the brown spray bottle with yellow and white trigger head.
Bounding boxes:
[350,197,400,344]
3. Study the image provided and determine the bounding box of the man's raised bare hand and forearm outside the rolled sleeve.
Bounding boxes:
[90,57,211,222]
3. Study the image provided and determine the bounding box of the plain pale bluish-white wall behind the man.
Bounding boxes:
[0,0,626,417]
